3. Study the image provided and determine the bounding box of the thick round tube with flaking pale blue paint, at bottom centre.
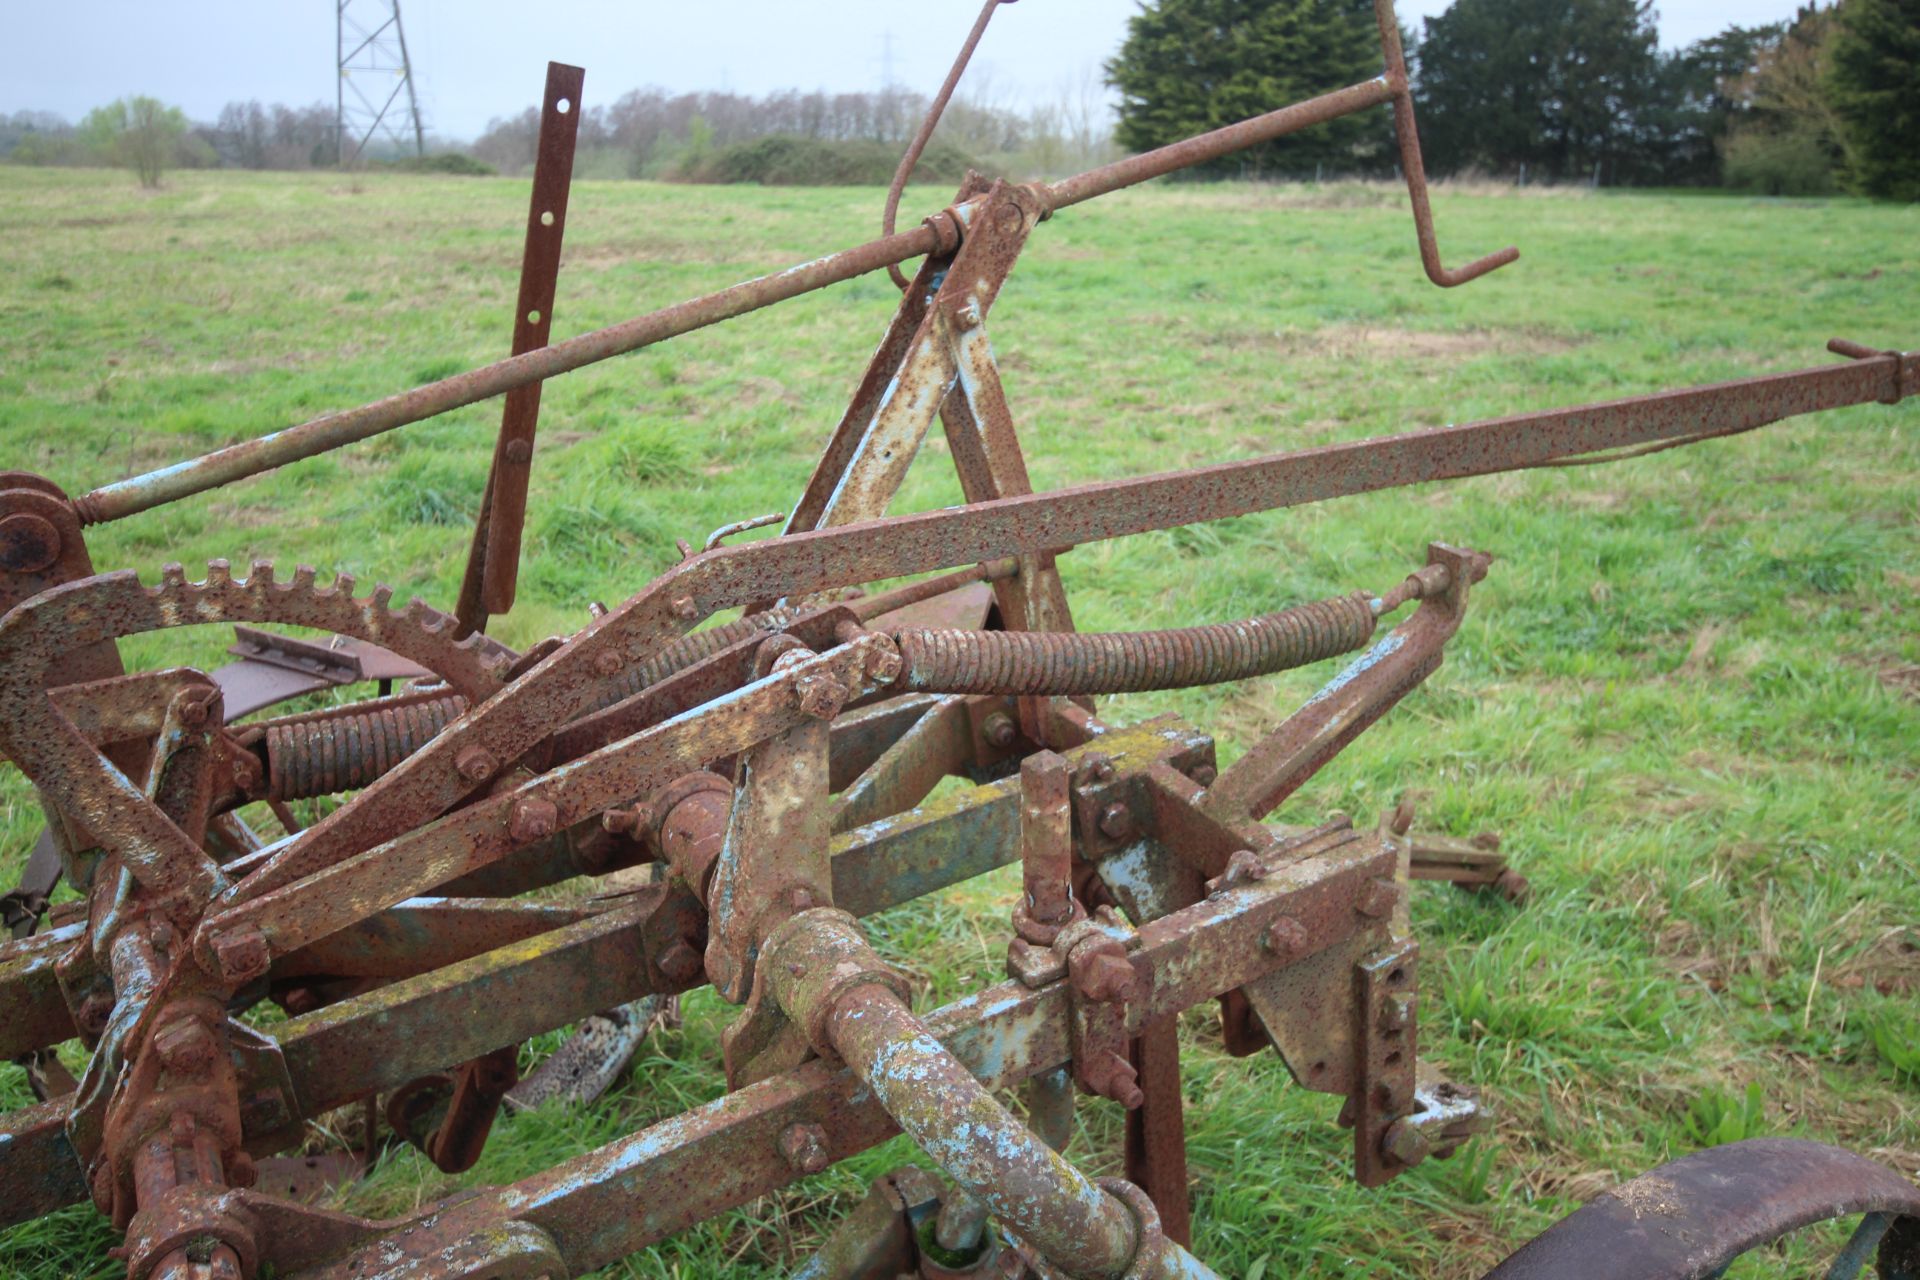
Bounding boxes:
[828,984,1213,1280]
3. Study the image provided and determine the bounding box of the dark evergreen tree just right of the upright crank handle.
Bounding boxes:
[1417,0,1676,182]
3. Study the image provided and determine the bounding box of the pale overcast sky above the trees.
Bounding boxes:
[0,0,1795,138]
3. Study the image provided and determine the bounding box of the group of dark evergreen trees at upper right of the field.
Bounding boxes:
[1108,0,1920,200]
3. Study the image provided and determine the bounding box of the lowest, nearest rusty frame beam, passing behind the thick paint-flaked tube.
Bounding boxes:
[292,842,1392,1280]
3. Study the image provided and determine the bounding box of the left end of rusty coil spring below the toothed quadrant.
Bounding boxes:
[267,695,467,800]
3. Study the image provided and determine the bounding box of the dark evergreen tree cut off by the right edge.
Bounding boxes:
[1826,0,1920,200]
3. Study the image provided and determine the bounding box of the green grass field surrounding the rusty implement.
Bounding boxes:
[0,169,1920,1280]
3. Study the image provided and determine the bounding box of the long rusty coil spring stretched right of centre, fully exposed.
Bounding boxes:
[895,593,1375,697]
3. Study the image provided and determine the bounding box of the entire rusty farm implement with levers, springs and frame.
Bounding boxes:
[0,0,1920,1280]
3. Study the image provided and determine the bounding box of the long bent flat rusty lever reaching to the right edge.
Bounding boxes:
[228,355,1920,927]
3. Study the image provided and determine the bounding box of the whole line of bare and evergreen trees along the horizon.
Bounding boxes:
[0,0,1920,200]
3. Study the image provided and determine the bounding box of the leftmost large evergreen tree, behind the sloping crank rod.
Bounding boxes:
[1106,0,1392,175]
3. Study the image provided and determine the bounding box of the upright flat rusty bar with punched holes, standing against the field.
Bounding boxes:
[455,61,588,631]
